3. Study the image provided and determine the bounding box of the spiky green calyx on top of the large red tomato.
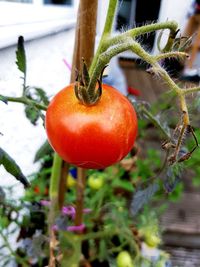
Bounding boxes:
[74,58,104,106]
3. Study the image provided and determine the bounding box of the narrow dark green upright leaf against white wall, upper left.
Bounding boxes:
[16,36,26,75]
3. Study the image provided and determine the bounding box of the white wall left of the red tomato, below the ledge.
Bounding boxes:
[0,30,74,197]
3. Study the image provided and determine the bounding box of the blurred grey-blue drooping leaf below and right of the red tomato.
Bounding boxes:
[131,182,159,215]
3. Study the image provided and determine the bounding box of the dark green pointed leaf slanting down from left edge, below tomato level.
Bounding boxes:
[0,148,30,187]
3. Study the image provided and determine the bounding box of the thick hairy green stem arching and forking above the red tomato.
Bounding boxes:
[87,20,179,95]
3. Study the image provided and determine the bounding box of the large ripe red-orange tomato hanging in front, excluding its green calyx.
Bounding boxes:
[46,84,137,169]
